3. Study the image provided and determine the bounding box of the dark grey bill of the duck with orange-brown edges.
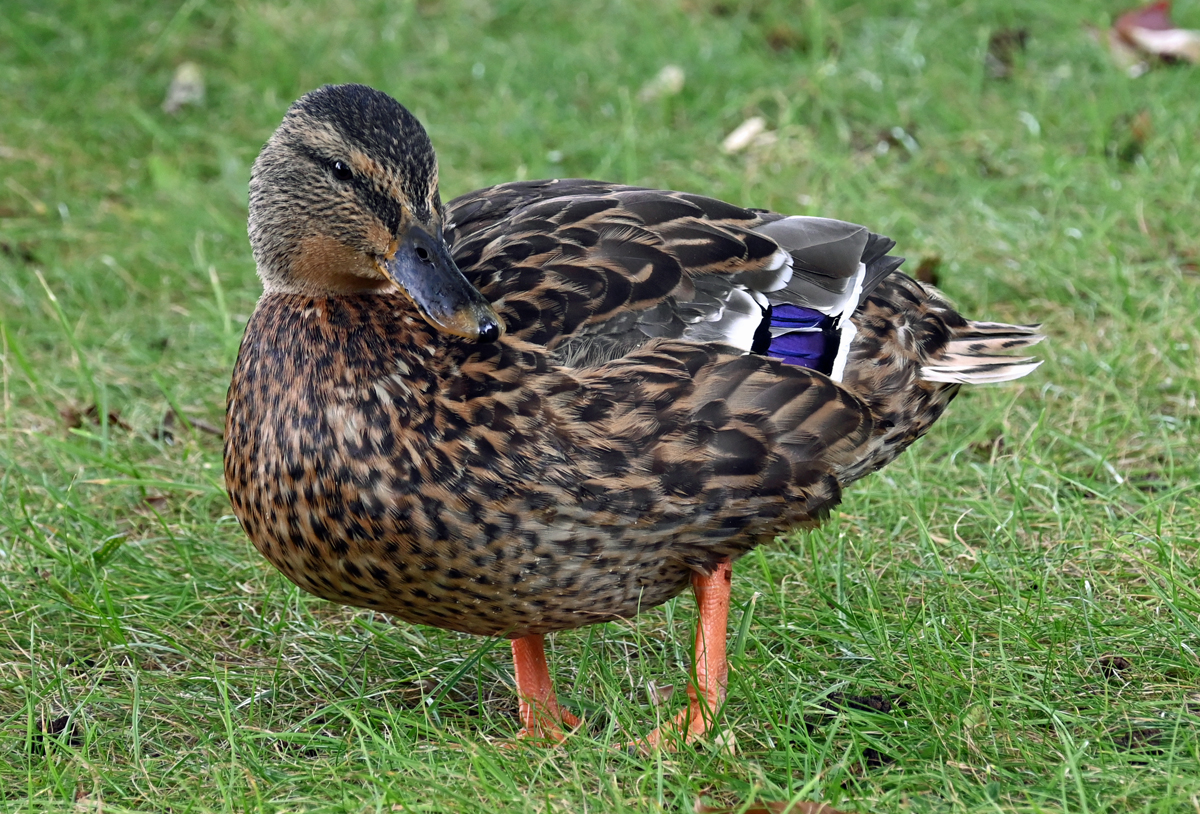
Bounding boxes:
[383,226,504,342]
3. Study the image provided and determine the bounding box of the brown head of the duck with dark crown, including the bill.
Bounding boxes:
[250,85,504,342]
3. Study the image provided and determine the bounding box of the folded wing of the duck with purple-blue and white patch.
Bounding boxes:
[445,180,902,378]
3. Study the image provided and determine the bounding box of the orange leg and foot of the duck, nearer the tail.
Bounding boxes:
[635,559,733,750]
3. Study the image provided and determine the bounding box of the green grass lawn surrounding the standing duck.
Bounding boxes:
[0,0,1200,814]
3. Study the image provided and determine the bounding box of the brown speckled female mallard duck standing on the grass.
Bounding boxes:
[224,85,1042,746]
